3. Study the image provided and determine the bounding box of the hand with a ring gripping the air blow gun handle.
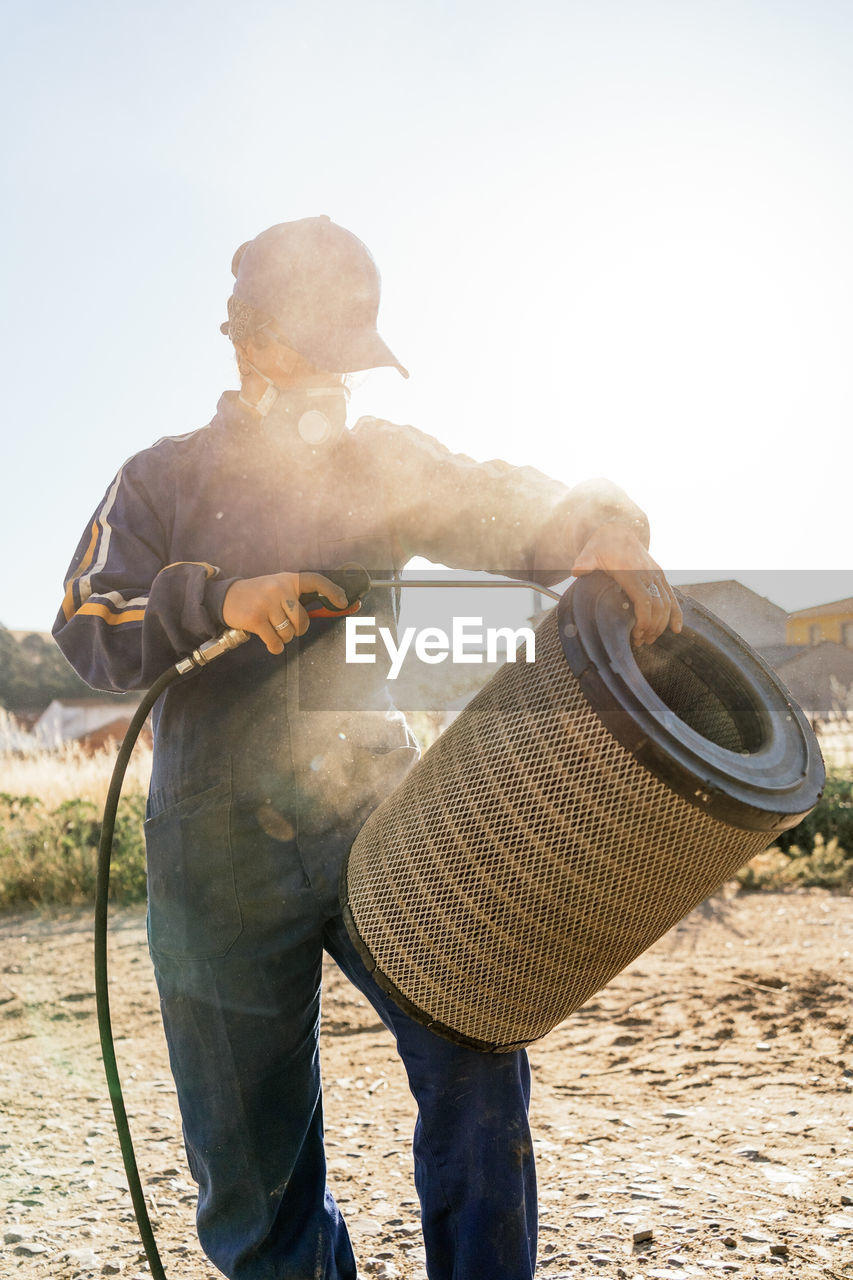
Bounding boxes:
[222,573,348,653]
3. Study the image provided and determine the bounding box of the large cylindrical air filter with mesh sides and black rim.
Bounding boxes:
[342,573,824,1052]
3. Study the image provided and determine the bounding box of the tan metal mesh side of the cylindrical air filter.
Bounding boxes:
[347,613,771,1050]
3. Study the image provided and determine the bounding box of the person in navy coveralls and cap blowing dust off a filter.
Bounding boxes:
[54,216,680,1280]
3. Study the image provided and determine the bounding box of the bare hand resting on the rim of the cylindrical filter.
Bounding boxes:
[571,520,683,645]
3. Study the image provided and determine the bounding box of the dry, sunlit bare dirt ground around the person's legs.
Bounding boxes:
[0,892,853,1280]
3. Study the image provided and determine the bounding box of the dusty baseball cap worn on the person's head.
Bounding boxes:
[222,215,409,378]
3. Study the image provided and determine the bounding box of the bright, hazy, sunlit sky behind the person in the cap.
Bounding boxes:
[0,0,853,630]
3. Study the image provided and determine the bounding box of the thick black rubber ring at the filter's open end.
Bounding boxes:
[557,572,825,832]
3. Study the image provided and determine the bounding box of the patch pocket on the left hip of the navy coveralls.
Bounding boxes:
[145,780,243,960]
